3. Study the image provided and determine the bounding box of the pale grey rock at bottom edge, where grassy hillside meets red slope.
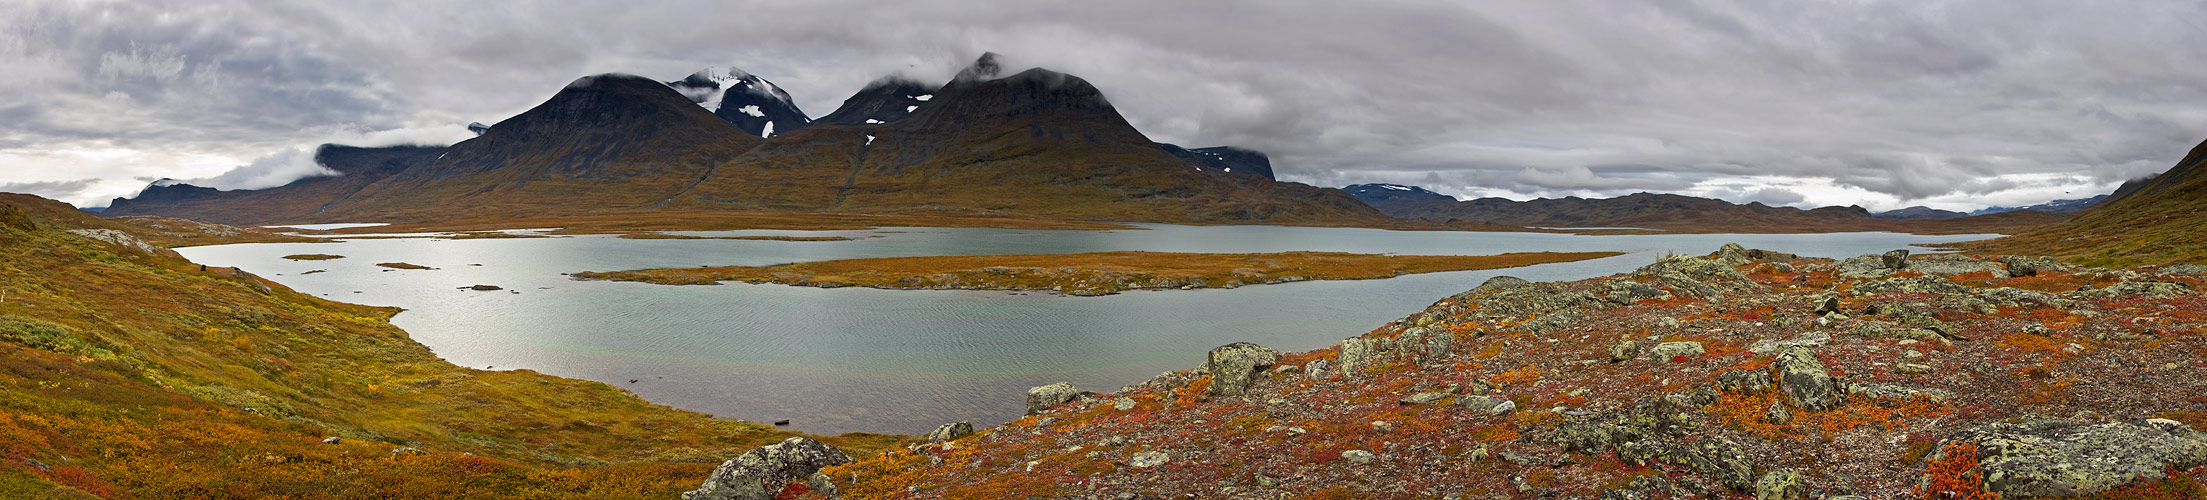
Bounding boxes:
[682,436,852,500]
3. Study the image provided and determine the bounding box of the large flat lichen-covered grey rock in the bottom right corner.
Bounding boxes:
[1933,421,2207,498]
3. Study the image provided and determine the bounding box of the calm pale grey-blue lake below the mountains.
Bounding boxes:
[179,225,1993,434]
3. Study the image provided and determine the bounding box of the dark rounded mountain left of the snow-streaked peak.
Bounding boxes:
[306,73,761,220]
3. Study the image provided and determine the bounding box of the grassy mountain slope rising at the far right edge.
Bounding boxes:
[1955,132,2207,267]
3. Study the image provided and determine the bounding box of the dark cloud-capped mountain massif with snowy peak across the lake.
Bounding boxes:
[106,53,1388,225]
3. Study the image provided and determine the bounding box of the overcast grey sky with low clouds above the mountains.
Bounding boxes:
[0,0,2207,209]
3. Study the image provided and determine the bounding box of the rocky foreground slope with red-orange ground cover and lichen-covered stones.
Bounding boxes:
[693,244,2207,498]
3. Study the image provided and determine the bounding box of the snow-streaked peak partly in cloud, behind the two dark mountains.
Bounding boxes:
[667,68,812,137]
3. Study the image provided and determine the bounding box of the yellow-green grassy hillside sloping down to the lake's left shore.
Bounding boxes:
[0,194,894,498]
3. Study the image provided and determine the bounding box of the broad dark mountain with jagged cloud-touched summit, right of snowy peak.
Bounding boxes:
[669,55,1386,222]
